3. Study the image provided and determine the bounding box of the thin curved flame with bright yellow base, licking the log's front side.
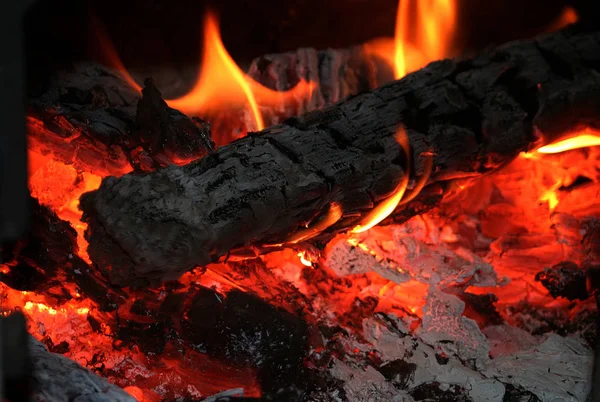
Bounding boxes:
[351,127,418,233]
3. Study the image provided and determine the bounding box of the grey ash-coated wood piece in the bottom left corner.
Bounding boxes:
[28,336,136,402]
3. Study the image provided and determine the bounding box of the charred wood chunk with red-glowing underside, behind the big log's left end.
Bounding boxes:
[27,64,216,176]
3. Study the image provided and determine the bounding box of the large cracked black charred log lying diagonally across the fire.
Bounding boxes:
[80,29,600,286]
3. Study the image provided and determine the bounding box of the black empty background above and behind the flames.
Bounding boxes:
[25,0,600,92]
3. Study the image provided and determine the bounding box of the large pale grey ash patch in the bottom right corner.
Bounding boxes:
[322,304,593,402]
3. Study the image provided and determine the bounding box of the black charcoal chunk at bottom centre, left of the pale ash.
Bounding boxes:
[181,287,309,394]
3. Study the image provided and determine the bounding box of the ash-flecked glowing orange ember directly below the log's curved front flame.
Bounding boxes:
[322,217,498,287]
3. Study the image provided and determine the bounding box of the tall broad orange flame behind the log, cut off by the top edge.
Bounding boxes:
[394,0,456,79]
